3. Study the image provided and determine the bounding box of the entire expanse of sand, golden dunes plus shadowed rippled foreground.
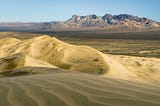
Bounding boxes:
[0,33,160,106]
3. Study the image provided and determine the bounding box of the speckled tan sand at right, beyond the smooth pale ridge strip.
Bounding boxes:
[107,54,160,83]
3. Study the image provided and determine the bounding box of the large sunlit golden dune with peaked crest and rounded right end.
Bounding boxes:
[0,35,109,74]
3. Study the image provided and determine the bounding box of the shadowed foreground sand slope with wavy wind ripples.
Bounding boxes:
[0,72,160,106]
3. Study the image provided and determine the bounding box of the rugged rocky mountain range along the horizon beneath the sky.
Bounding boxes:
[0,14,160,31]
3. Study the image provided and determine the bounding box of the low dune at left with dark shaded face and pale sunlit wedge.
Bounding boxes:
[0,53,56,73]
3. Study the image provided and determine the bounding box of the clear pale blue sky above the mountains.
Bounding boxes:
[0,0,160,22]
